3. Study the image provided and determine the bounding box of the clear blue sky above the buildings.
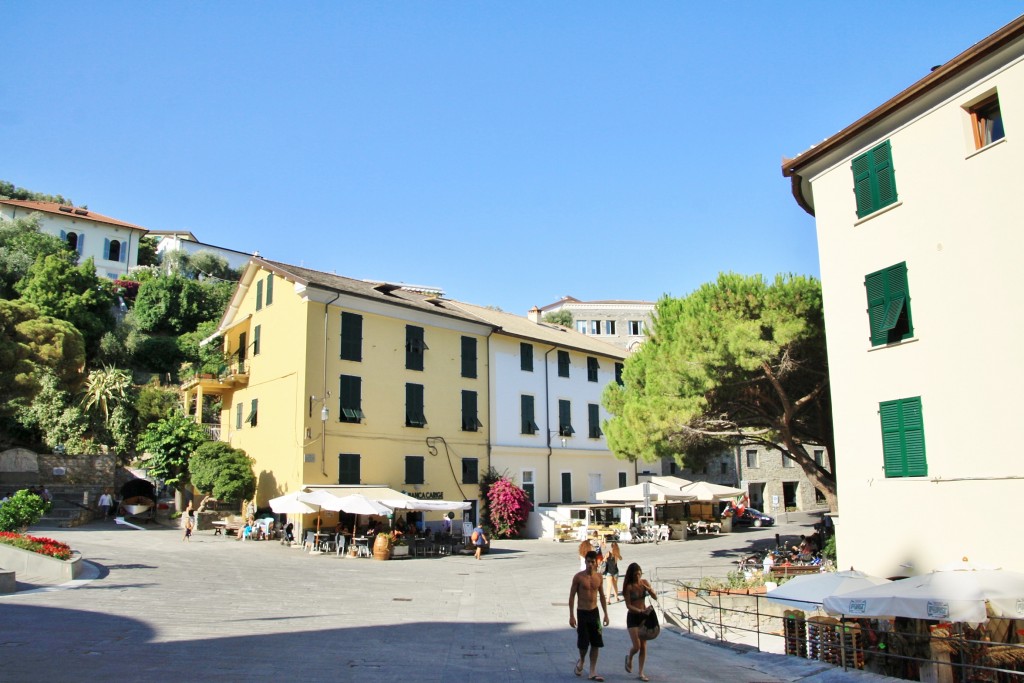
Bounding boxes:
[0,0,1024,314]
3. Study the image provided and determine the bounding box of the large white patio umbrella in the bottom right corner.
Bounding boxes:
[824,569,1024,623]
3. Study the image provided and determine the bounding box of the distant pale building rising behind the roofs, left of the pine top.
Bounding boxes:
[537,296,654,353]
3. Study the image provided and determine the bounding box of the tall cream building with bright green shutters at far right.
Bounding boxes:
[782,17,1024,575]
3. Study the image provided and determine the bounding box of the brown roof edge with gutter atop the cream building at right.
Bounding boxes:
[782,15,1024,214]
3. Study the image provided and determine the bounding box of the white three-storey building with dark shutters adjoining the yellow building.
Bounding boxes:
[456,302,636,536]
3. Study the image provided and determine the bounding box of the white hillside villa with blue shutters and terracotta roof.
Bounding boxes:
[0,199,146,280]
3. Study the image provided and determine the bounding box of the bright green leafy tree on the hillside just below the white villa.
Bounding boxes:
[15,254,114,357]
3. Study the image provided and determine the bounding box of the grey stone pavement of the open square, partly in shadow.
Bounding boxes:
[0,515,891,683]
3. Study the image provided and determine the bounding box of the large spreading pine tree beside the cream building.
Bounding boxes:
[603,273,836,509]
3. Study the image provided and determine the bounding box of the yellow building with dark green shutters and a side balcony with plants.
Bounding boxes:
[185,257,493,523]
